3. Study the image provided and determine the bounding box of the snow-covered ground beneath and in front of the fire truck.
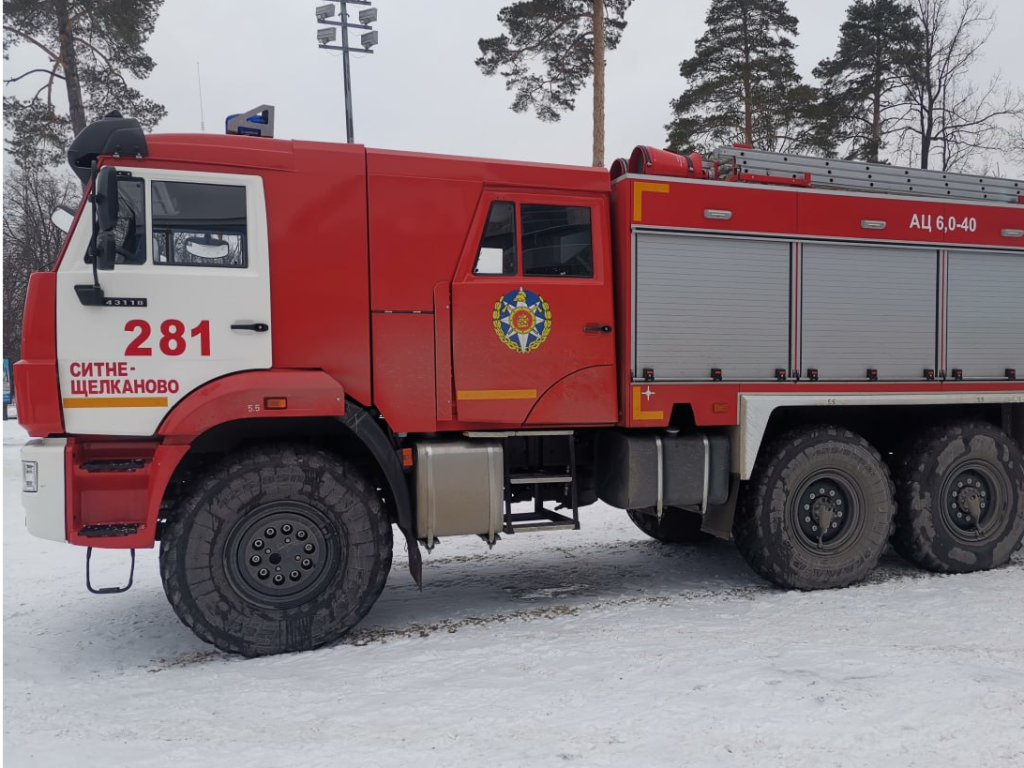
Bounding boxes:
[3,422,1024,768]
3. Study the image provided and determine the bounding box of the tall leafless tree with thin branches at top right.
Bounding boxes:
[896,0,1024,171]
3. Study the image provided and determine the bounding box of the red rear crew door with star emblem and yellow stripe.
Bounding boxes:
[452,194,618,426]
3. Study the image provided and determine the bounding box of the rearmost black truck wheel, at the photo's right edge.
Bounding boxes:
[892,422,1024,573]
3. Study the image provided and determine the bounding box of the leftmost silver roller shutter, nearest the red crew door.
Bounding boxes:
[634,232,790,381]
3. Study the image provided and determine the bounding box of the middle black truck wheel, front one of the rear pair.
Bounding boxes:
[732,426,896,590]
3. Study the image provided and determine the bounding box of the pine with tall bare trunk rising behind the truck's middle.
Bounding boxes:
[476,0,633,167]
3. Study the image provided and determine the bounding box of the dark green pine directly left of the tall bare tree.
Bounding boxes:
[814,0,924,163]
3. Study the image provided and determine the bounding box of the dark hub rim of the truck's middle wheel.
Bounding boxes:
[790,470,863,554]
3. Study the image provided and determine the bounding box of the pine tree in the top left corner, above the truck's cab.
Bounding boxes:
[2,0,167,165]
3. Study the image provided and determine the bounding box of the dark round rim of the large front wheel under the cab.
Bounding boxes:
[224,502,341,608]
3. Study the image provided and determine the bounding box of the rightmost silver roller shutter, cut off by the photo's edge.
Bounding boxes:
[946,251,1024,379]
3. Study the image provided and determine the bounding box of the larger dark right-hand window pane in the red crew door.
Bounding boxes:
[520,204,594,278]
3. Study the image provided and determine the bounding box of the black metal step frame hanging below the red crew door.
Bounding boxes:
[503,430,580,534]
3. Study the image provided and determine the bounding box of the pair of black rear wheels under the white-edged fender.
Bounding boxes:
[733,422,1024,590]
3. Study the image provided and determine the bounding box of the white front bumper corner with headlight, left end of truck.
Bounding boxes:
[22,437,68,542]
